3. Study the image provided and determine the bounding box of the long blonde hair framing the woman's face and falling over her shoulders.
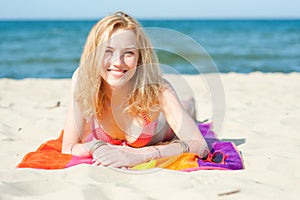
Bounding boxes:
[74,12,162,119]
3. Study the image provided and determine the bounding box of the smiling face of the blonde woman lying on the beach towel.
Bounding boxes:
[102,29,139,89]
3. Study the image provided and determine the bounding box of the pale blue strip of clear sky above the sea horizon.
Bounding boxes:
[0,0,300,20]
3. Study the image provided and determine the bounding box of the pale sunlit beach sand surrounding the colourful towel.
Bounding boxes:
[0,73,300,200]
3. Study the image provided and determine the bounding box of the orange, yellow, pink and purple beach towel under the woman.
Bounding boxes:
[17,123,244,172]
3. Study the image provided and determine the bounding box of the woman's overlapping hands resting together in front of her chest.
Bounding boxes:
[93,144,147,168]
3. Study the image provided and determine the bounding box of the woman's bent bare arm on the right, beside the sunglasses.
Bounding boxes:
[133,82,208,159]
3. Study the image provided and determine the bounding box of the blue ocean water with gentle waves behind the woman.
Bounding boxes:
[0,20,300,79]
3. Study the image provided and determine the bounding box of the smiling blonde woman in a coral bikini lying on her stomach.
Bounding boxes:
[62,12,207,167]
